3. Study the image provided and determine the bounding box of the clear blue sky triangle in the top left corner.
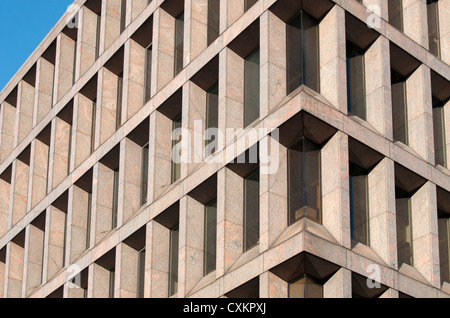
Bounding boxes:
[0,0,73,91]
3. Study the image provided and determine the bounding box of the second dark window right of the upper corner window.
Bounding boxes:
[391,69,408,145]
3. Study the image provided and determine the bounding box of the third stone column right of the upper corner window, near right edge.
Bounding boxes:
[406,65,434,164]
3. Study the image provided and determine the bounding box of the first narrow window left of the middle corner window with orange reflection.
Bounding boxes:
[244,170,259,252]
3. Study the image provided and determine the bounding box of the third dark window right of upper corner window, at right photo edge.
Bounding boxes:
[433,101,447,167]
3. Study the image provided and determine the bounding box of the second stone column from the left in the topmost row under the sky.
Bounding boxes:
[14,80,35,146]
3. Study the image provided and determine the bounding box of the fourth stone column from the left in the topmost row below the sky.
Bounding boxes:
[53,32,77,103]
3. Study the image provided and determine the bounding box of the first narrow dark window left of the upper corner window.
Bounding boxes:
[244,48,259,127]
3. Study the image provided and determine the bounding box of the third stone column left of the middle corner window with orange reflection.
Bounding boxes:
[178,196,205,297]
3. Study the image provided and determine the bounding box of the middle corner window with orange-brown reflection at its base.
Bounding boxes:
[288,137,322,225]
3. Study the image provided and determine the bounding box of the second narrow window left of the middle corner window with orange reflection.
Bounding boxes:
[203,201,217,276]
